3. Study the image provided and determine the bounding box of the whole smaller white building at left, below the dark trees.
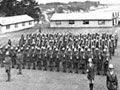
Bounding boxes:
[0,15,34,33]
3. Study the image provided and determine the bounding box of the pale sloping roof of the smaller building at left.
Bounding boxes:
[0,15,34,25]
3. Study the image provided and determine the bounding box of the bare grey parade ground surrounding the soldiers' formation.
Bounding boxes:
[0,27,120,90]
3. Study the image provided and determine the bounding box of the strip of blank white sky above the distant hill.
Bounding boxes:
[36,0,120,4]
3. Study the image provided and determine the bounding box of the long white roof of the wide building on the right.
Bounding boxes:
[50,12,113,20]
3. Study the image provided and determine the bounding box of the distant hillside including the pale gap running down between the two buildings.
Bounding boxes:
[39,1,106,22]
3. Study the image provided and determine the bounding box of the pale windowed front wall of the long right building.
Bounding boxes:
[50,20,113,27]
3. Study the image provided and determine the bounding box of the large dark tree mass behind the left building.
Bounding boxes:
[0,0,41,20]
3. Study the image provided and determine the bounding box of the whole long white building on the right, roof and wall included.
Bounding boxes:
[50,12,117,28]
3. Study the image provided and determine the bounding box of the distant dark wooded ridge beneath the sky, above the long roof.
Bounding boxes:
[39,1,104,12]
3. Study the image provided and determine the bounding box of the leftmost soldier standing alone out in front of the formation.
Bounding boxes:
[3,51,12,82]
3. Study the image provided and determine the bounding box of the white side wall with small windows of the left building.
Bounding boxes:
[1,21,34,33]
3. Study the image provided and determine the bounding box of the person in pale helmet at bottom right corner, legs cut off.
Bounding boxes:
[106,64,118,90]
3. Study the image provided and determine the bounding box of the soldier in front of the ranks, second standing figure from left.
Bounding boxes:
[16,49,23,74]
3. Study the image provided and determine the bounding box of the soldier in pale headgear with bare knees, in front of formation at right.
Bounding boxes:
[87,58,95,90]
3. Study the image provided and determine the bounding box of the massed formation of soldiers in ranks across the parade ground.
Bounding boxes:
[0,33,118,74]
